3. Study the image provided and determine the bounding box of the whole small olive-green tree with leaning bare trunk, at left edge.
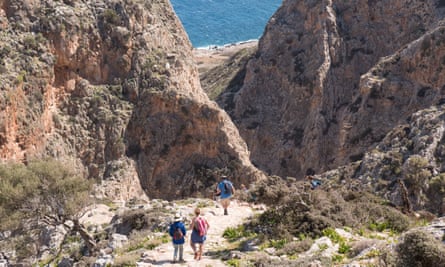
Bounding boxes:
[0,160,95,264]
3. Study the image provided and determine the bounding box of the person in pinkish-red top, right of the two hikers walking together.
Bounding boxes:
[190,208,210,260]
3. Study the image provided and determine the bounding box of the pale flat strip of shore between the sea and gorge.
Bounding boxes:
[193,40,258,73]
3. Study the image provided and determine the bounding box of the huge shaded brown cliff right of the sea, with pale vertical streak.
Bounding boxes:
[228,0,445,180]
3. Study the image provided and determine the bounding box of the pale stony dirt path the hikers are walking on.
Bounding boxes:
[142,201,258,267]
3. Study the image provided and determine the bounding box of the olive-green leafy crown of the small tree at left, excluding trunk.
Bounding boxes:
[0,160,92,233]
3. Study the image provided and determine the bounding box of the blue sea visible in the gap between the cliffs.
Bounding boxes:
[170,0,282,48]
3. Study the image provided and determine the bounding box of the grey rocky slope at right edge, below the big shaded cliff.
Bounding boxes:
[351,105,445,216]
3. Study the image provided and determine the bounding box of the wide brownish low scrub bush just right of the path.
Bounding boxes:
[248,178,411,243]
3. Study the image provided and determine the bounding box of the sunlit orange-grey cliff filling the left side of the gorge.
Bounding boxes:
[0,0,261,199]
